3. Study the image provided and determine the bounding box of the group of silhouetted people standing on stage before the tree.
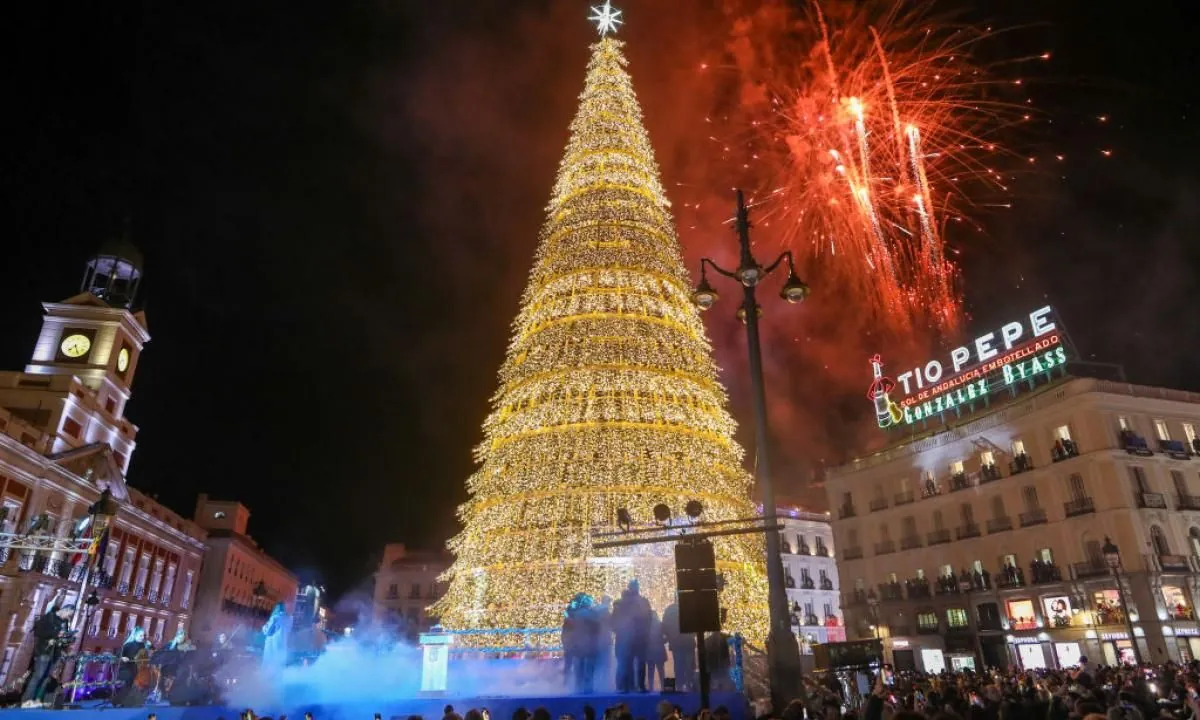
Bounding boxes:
[562,580,731,694]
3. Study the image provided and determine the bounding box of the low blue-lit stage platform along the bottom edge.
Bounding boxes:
[0,692,754,720]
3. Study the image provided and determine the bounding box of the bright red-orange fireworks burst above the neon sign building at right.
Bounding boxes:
[704,0,1030,331]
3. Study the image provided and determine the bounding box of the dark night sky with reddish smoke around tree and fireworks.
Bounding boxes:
[0,0,1200,593]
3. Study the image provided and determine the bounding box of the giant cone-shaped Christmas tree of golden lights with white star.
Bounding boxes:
[431,5,767,648]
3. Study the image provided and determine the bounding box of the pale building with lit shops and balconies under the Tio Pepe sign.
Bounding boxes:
[826,379,1200,670]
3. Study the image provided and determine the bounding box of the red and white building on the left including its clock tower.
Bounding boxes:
[0,245,205,682]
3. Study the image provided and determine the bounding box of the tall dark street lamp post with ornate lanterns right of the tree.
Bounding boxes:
[692,190,809,710]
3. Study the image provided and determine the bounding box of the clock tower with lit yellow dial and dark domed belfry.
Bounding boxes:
[0,239,150,474]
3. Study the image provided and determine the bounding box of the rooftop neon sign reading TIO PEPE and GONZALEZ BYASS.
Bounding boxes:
[868,305,1067,427]
